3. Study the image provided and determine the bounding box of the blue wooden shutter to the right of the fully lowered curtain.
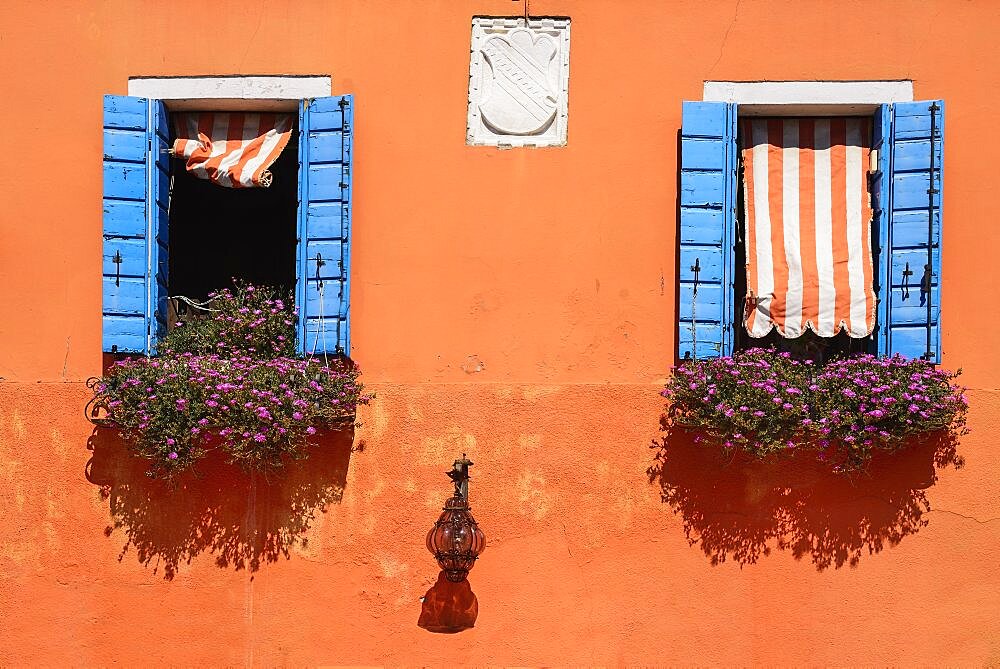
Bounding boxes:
[879,100,944,363]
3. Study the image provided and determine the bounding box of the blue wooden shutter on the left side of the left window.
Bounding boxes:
[102,95,170,354]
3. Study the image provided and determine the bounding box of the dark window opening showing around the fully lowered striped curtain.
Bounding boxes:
[733,118,879,363]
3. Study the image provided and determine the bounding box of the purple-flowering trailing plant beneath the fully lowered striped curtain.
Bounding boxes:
[661,349,968,471]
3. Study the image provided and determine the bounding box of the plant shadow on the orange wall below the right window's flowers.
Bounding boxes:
[648,428,961,571]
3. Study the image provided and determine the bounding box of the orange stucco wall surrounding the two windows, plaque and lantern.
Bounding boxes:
[0,0,1000,665]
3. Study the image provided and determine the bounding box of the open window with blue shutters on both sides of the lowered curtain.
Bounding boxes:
[677,96,944,362]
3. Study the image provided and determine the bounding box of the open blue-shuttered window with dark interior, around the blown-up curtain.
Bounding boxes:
[103,96,353,355]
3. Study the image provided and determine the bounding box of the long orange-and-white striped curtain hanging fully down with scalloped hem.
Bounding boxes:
[741,117,875,338]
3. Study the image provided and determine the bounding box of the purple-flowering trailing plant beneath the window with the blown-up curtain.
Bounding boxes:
[92,285,371,477]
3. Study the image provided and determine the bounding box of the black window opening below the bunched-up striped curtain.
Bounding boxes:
[168,117,298,308]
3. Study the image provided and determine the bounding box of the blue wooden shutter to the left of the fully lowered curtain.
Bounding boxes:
[677,102,737,360]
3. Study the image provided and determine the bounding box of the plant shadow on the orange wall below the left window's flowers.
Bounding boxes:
[86,426,354,580]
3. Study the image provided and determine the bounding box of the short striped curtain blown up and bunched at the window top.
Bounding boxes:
[172,112,292,188]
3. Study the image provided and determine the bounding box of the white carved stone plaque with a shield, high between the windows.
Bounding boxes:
[466,17,569,147]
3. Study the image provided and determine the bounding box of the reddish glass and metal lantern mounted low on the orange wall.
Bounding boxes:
[427,453,486,583]
